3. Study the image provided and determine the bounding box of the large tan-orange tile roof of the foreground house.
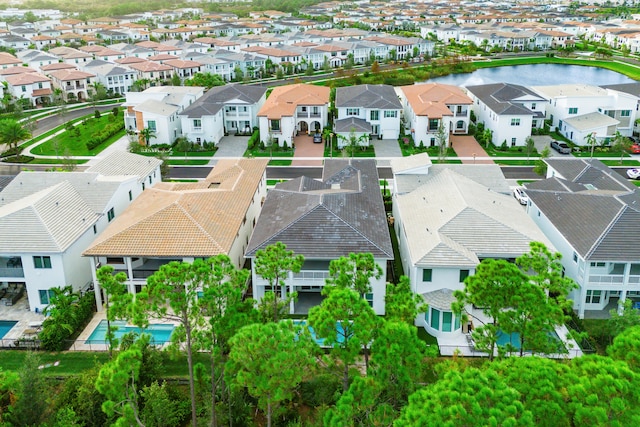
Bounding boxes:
[84,159,268,257]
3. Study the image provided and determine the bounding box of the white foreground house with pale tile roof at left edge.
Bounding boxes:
[0,151,161,311]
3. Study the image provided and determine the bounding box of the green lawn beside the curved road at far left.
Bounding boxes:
[33,114,126,156]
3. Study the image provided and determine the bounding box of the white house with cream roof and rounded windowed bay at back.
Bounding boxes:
[391,153,553,353]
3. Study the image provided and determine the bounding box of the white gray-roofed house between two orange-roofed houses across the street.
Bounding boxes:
[333,85,402,148]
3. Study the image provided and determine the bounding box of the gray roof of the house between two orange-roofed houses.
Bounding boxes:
[336,85,402,110]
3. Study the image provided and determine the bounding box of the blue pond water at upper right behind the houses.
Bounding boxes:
[428,64,636,87]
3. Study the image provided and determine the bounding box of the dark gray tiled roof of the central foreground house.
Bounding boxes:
[246,159,393,259]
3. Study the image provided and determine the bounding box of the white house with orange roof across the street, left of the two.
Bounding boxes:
[258,84,330,147]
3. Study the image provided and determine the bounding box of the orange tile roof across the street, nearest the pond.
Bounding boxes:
[400,83,473,119]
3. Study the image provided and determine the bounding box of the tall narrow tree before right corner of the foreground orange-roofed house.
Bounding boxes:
[199,255,255,426]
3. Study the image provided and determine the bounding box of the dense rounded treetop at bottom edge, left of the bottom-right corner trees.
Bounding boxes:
[393,368,534,427]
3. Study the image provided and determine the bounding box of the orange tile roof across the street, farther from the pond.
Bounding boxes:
[258,83,331,119]
